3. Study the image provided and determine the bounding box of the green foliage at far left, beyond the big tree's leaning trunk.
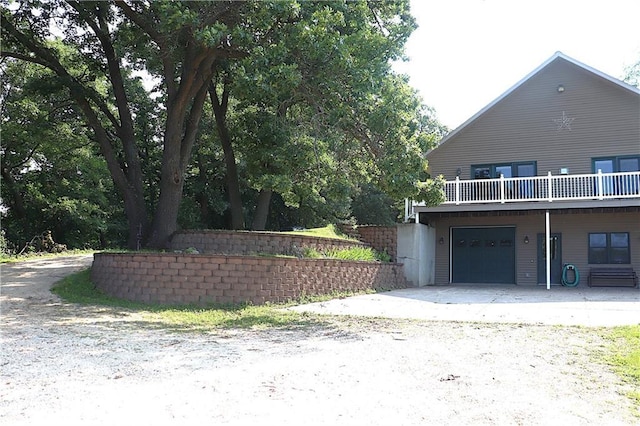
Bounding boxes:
[0,60,123,248]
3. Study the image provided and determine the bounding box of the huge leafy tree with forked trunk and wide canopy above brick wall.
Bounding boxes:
[1,0,444,248]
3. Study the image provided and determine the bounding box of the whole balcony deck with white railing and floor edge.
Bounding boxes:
[405,171,640,219]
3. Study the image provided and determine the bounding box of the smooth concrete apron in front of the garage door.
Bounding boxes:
[291,285,640,327]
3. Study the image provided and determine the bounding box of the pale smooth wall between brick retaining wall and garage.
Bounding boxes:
[397,223,436,287]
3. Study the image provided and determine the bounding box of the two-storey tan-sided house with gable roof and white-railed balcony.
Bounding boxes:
[399,52,640,286]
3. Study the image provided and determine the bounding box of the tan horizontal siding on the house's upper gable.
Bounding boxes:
[427,59,640,179]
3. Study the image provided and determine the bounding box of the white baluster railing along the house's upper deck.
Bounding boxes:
[407,171,640,218]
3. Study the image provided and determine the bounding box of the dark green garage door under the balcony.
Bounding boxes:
[451,227,516,284]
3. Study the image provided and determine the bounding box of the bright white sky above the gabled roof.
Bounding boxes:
[395,0,640,129]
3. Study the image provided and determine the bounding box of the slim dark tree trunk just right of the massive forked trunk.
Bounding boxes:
[209,85,245,229]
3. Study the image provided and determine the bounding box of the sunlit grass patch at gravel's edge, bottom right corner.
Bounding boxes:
[605,325,640,417]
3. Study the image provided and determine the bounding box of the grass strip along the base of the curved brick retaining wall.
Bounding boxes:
[51,269,362,331]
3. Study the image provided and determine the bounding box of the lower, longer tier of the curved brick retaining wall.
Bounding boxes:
[91,253,407,305]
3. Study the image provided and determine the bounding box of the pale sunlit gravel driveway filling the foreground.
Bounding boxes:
[0,257,640,425]
